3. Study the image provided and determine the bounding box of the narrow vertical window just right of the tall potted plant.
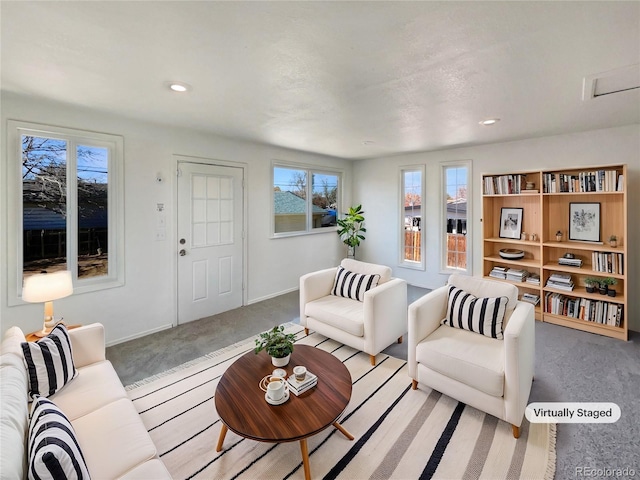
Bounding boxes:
[400,166,425,270]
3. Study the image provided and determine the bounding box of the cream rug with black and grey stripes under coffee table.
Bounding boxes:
[127,324,555,479]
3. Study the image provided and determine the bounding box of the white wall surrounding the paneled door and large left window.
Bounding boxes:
[0,92,352,344]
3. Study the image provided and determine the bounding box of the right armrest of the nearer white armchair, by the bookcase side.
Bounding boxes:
[504,301,536,426]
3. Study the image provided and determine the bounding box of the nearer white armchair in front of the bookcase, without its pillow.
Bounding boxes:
[407,274,535,438]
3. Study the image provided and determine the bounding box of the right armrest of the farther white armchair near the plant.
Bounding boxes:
[363,278,407,352]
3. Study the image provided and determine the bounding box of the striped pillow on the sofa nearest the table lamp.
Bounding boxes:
[22,324,78,397]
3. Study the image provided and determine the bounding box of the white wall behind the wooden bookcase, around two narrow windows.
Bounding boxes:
[353,125,640,331]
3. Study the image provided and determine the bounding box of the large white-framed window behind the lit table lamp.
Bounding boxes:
[9,122,123,302]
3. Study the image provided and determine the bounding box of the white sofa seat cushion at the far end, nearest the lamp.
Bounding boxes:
[51,360,127,421]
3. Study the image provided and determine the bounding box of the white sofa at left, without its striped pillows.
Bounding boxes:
[0,323,171,480]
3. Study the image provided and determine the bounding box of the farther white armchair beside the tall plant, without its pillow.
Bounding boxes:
[300,259,407,365]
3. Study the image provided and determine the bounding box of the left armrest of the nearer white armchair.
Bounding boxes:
[407,286,447,379]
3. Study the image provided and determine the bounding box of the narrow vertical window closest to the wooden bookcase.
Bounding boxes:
[442,161,472,272]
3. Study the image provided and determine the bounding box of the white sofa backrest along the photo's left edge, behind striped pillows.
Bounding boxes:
[0,327,29,479]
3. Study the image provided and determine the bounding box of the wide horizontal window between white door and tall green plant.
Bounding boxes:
[273,164,341,236]
